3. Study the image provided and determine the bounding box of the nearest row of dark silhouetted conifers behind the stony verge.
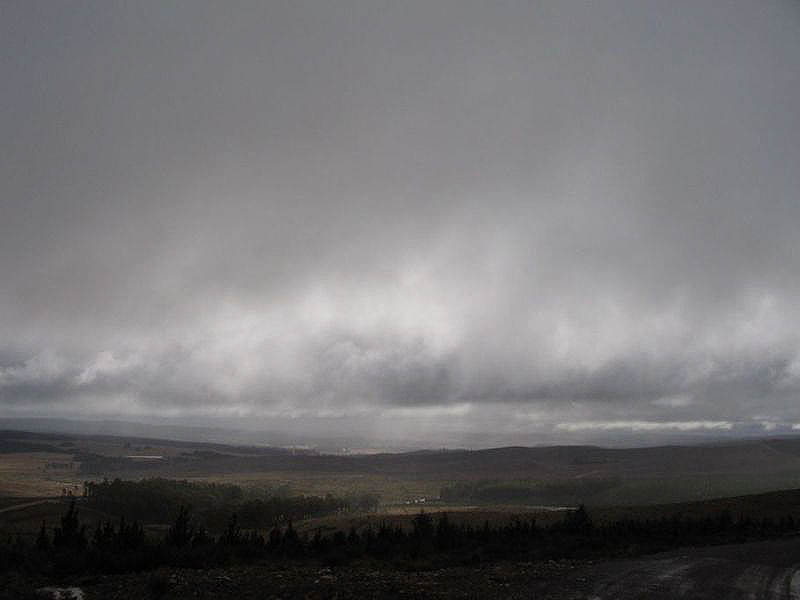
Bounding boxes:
[0,502,798,575]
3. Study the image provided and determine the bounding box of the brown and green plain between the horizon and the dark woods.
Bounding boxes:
[6,431,800,507]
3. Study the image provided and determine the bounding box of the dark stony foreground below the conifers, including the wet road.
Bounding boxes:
[9,537,800,600]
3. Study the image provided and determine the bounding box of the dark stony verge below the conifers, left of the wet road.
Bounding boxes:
[4,561,579,600]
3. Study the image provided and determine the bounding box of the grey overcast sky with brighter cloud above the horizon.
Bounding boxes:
[0,0,800,445]
